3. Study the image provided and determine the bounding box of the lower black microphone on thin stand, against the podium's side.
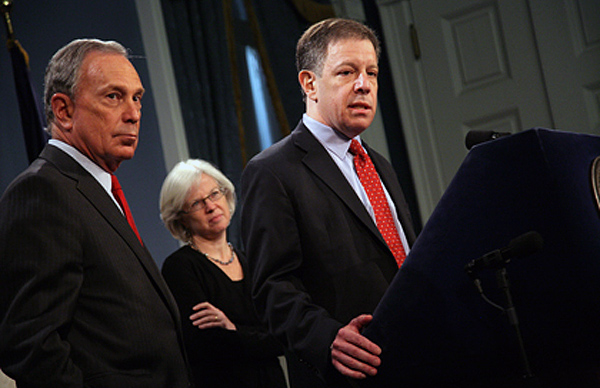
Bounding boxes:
[465,230,544,276]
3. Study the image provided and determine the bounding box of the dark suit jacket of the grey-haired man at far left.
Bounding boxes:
[0,145,189,388]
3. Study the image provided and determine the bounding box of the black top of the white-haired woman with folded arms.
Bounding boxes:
[162,246,286,388]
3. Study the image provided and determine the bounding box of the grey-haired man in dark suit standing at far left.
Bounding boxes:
[0,39,189,388]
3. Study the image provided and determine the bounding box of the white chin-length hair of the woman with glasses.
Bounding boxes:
[160,159,236,243]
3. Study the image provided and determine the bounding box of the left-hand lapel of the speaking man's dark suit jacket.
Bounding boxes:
[292,123,387,246]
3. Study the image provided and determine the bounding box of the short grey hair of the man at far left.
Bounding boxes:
[44,39,129,131]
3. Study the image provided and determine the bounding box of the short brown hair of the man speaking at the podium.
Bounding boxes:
[296,18,381,76]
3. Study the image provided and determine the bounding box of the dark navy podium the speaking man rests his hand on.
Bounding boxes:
[361,128,600,388]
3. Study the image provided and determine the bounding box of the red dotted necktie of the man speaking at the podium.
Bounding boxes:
[350,139,406,267]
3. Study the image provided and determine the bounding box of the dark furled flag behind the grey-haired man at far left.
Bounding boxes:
[7,39,48,163]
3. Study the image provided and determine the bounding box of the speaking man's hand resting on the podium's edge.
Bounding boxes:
[331,315,381,379]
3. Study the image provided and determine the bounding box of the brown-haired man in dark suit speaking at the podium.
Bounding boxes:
[242,19,415,387]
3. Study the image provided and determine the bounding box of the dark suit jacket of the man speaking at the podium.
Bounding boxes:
[242,123,415,379]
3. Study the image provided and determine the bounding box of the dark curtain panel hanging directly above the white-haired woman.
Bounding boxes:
[161,0,244,242]
